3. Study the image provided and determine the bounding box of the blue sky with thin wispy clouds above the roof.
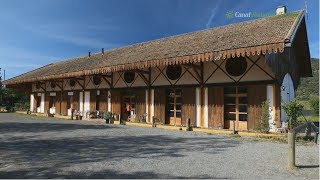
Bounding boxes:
[0,0,319,79]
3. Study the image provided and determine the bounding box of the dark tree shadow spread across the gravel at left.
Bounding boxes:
[0,118,235,178]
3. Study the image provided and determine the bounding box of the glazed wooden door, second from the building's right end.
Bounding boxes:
[167,89,182,126]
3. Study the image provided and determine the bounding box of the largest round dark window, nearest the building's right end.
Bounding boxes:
[225,57,247,76]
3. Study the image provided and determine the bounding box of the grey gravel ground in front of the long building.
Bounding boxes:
[0,113,319,179]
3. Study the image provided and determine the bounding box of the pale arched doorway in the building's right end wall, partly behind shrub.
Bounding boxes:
[280,73,295,122]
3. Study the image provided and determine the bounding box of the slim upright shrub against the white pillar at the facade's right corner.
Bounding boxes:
[257,101,270,133]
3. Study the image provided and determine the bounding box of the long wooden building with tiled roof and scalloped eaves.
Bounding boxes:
[4,9,312,130]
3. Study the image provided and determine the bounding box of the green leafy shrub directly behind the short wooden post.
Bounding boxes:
[282,99,303,130]
